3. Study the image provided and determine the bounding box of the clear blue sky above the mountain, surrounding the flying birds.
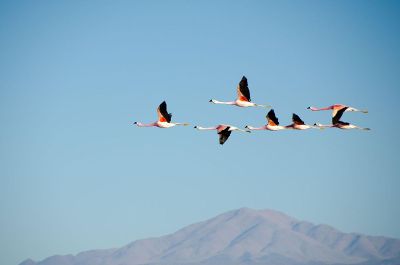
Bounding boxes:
[0,1,400,264]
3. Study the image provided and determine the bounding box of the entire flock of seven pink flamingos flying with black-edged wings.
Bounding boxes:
[134,76,370,145]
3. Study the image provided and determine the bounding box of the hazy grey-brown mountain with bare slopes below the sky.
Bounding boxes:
[20,208,400,265]
